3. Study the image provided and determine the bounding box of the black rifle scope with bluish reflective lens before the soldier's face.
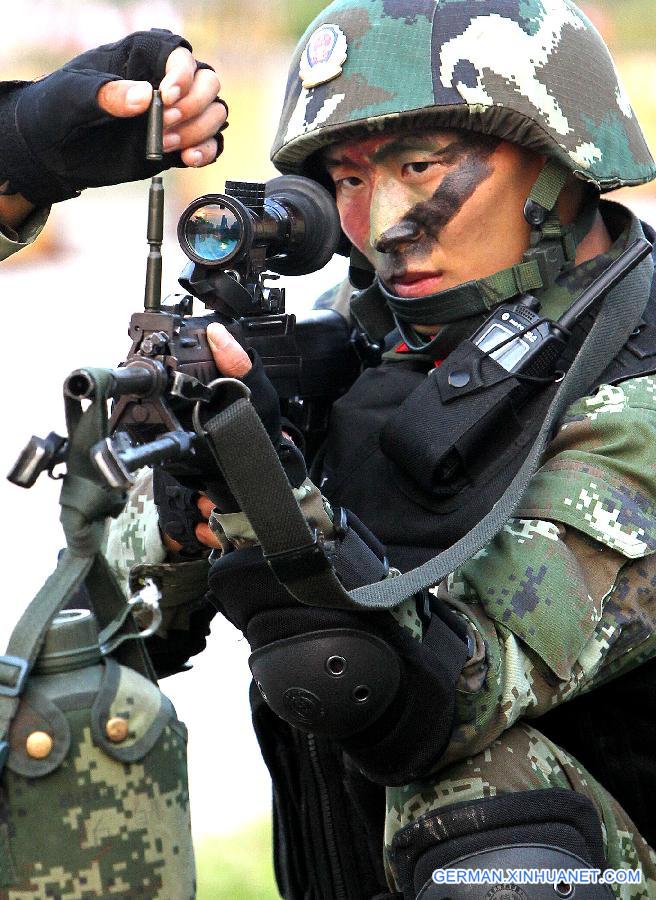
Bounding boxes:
[178,175,341,275]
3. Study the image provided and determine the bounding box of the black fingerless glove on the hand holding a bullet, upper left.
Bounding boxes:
[0,29,221,206]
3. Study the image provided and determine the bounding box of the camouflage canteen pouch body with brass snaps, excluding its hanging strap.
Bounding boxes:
[0,658,195,900]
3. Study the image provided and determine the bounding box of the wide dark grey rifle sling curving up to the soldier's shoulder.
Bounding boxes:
[205,246,654,610]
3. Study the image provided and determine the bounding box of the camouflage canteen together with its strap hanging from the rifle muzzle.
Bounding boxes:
[0,370,195,900]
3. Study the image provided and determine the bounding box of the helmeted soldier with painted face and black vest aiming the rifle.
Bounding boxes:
[108,0,656,900]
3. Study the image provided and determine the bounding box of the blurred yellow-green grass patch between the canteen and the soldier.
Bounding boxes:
[194,820,280,900]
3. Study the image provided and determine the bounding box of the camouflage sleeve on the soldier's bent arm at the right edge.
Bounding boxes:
[438,377,656,767]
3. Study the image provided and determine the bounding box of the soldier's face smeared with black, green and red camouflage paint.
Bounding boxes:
[323,130,544,308]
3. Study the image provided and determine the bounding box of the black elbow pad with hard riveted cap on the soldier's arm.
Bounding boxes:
[209,520,468,785]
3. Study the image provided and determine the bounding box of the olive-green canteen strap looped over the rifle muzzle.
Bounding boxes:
[0,369,154,756]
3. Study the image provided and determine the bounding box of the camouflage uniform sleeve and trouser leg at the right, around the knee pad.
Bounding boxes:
[386,377,656,898]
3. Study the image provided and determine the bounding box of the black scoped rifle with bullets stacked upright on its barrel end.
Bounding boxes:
[9,92,361,490]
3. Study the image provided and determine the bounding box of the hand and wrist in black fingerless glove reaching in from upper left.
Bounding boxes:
[0,29,227,259]
